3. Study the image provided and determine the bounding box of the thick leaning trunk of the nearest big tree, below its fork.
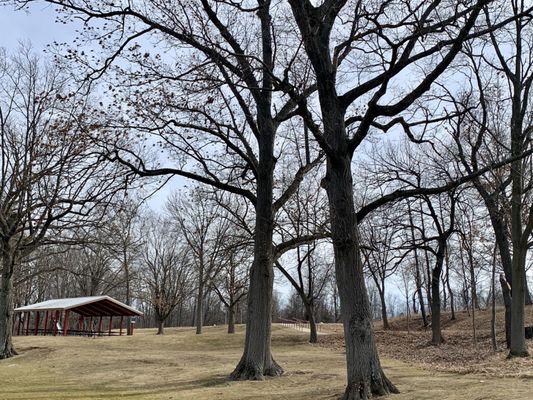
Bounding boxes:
[323,155,397,400]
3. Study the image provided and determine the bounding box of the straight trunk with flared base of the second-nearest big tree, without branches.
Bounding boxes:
[230,130,283,380]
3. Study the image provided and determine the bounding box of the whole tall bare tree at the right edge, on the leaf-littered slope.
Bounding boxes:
[448,0,533,356]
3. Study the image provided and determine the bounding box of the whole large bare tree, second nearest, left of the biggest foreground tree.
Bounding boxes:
[9,0,322,379]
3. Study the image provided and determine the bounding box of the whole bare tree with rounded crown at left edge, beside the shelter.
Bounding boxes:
[0,48,124,358]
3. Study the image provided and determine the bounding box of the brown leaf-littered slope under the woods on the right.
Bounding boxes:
[319,306,533,378]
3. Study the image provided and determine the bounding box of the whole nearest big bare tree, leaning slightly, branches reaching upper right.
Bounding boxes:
[282,0,508,399]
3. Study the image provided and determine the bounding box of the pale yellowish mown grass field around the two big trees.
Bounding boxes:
[0,326,533,400]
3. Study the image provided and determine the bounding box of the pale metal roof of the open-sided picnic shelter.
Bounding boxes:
[15,296,143,317]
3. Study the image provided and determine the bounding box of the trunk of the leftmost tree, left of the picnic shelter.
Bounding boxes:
[0,250,17,360]
